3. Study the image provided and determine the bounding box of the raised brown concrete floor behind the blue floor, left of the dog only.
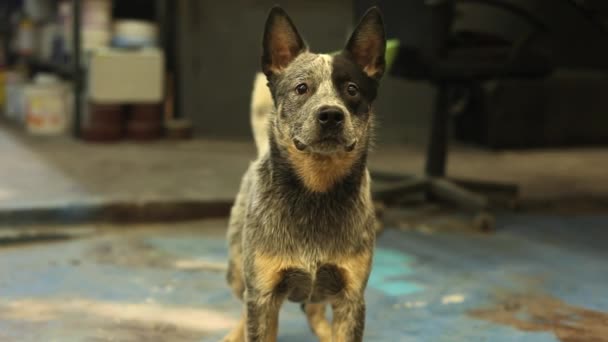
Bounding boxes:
[0,125,249,222]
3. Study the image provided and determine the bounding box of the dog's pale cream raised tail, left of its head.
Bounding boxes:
[251,72,274,157]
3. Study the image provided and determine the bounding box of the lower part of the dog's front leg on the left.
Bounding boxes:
[245,291,281,342]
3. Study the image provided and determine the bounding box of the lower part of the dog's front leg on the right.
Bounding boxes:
[332,296,365,342]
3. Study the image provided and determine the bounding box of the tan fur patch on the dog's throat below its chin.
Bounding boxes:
[288,144,358,192]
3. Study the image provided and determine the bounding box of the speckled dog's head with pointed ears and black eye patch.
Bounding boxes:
[262,7,386,156]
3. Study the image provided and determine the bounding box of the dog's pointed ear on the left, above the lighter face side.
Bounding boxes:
[262,6,306,76]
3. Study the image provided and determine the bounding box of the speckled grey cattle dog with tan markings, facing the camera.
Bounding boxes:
[223,7,386,342]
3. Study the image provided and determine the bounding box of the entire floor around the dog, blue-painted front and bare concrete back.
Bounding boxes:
[0,121,608,342]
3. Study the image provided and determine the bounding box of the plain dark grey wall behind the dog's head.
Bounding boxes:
[178,0,433,142]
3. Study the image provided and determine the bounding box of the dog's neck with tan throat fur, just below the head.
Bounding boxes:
[268,134,367,193]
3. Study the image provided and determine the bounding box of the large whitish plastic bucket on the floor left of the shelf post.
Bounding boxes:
[24,74,71,135]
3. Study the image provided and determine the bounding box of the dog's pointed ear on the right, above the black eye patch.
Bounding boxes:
[345,7,386,79]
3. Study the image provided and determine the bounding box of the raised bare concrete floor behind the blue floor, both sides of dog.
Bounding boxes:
[0,122,608,222]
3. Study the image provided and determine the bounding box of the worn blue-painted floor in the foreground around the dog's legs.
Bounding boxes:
[0,216,608,342]
